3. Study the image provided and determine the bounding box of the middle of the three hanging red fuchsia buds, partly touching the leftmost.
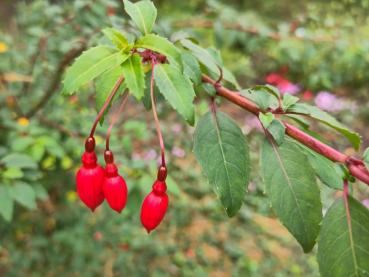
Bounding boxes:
[103,150,128,213]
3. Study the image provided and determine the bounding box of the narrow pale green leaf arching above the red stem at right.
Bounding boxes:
[288,103,361,149]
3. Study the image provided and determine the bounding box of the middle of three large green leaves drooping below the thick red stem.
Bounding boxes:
[261,139,322,252]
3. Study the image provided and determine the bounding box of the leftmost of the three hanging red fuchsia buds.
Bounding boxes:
[76,137,105,211]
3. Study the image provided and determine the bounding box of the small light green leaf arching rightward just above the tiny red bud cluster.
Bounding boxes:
[135,34,182,71]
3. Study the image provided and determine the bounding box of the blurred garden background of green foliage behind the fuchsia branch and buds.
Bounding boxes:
[0,0,369,276]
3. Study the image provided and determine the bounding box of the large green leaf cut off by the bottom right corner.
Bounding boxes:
[318,196,369,277]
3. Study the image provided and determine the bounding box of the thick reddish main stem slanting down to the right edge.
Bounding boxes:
[202,75,369,185]
